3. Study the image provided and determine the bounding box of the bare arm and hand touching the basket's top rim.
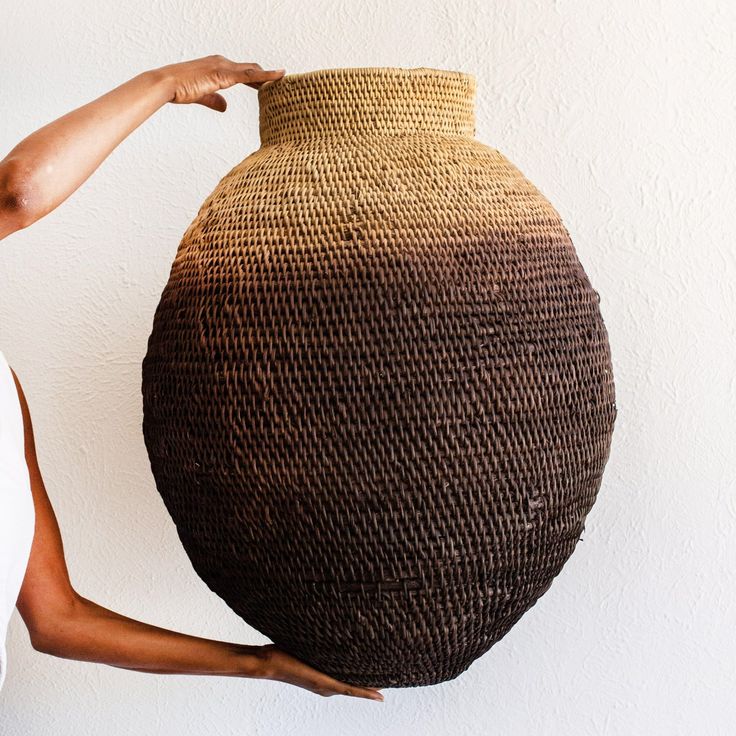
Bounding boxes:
[0,56,284,239]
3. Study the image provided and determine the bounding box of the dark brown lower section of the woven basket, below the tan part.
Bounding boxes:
[143,217,615,687]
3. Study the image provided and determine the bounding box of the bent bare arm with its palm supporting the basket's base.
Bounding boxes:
[13,374,383,700]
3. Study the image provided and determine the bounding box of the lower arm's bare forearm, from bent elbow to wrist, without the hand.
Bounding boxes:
[31,597,271,677]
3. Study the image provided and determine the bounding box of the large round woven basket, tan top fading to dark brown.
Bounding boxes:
[143,68,616,687]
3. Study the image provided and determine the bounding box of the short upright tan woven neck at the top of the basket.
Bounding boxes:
[258,67,475,145]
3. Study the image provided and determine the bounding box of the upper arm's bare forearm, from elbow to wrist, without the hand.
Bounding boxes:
[0,70,174,226]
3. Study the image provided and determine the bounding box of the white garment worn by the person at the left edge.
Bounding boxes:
[0,353,35,688]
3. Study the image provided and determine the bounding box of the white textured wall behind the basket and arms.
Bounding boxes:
[0,0,736,736]
